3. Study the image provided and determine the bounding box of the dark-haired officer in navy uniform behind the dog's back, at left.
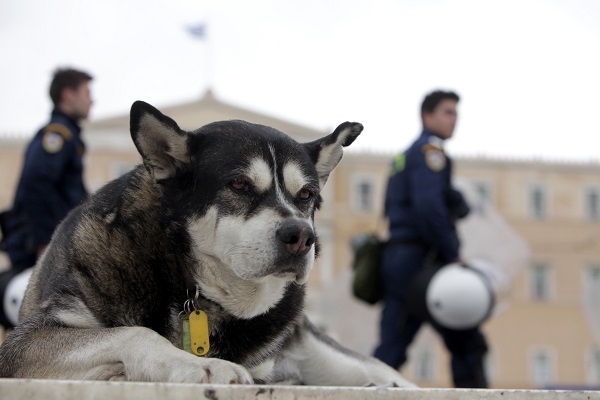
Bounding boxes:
[0,69,92,326]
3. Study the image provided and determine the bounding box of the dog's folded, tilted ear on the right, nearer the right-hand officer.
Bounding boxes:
[304,122,363,189]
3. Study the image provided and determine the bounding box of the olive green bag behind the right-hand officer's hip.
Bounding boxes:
[352,233,385,304]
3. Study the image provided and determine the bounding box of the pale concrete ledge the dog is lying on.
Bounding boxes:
[0,379,600,400]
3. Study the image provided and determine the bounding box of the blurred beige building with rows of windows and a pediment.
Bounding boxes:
[0,91,600,388]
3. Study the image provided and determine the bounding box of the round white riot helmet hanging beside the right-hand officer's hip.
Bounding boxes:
[426,263,494,330]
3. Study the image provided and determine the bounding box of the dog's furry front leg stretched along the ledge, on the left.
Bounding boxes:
[0,324,252,384]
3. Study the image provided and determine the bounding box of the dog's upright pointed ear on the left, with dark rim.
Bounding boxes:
[129,101,190,182]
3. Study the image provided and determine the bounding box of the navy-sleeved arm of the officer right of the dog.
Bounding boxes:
[409,152,459,262]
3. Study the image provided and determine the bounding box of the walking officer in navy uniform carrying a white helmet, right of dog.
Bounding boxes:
[375,91,487,388]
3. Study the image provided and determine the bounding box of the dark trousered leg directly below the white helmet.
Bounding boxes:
[434,326,488,388]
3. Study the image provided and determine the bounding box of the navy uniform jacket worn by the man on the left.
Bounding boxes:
[4,110,87,268]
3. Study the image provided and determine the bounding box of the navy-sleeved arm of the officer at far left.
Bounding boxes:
[22,133,76,249]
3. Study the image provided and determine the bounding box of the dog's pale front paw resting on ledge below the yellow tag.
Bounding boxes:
[168,357,254,384]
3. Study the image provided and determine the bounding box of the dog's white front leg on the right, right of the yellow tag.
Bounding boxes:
[275,318,415,387]
